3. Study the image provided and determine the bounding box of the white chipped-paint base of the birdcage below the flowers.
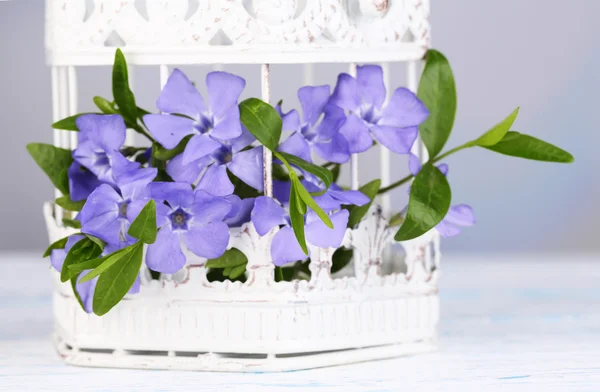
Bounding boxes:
[46,205,439,371]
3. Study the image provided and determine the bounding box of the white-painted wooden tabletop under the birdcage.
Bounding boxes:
[0,254,600,392]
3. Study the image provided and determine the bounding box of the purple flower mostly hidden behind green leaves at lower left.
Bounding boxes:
[50,235,141,313]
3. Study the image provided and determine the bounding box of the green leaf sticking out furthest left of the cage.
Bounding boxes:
[27,143,73,195]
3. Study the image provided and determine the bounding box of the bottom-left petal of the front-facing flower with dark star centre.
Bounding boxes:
[146,225,186,274]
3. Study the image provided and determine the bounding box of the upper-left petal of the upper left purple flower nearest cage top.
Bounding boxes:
[156,68,207,118]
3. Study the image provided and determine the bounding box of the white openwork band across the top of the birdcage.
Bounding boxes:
[46,0,430,65]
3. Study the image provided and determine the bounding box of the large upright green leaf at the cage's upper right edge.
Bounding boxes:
[417,49,457,158]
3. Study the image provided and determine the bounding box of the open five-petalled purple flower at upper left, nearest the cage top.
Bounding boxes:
[144,69,246,165]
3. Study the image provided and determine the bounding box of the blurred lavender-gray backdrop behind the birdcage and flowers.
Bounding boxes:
[0,0,600,252]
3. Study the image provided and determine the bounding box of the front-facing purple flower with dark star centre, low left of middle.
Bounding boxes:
[146,182,231,274]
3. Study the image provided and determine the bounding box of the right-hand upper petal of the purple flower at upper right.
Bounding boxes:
[378,88,429,128]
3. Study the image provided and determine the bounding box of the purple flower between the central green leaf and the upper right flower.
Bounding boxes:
[277,86,350,163]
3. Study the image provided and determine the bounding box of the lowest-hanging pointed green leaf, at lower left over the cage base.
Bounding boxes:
[92,242,143,316]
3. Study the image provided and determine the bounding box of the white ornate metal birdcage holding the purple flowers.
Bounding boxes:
[44,0,440,371]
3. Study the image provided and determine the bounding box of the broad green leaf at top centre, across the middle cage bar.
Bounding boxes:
[240,98,282,151]
